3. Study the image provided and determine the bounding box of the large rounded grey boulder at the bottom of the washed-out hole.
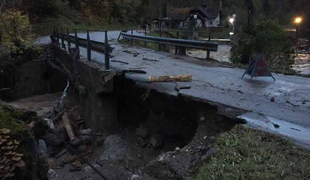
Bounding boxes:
[100,135,129,161]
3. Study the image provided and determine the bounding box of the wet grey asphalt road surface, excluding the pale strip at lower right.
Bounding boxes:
[41,32,310,144]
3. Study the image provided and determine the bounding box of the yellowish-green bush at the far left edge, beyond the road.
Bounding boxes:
[2,10,33,54]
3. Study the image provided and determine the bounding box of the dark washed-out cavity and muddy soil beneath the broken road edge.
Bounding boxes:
[41,78,236,180]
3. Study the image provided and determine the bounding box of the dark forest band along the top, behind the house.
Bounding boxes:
[0,0,310,34]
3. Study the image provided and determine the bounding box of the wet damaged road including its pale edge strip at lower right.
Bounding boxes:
[42,31,310,147]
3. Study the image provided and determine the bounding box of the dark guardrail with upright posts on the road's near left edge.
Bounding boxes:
[51,29,113,70]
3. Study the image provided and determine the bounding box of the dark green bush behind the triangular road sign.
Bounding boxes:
[231,18,294,70]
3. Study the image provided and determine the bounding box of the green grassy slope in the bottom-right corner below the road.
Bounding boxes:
[191,125,310,180]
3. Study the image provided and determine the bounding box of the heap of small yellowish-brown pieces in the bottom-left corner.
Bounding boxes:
[0,129,25,179]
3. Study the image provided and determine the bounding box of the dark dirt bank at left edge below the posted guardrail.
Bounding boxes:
[0,49,66,101]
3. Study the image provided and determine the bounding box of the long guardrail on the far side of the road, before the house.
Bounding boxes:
[121,32,218,58]
